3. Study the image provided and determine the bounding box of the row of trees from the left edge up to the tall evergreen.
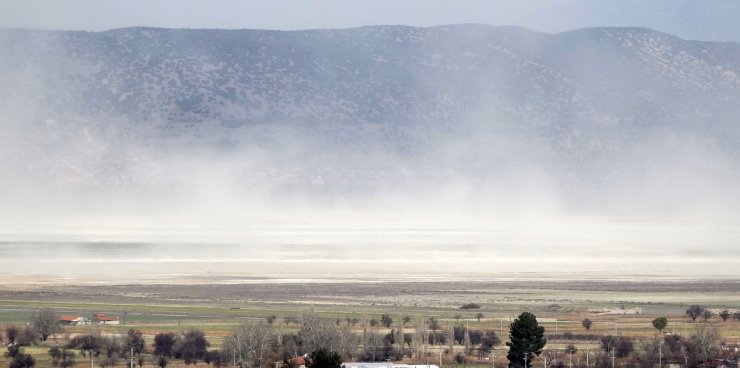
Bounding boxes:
[5,309,499,368]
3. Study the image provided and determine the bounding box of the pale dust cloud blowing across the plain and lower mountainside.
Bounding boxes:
[0,25,740,280]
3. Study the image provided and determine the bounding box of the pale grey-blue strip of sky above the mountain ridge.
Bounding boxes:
[0,0,740,42]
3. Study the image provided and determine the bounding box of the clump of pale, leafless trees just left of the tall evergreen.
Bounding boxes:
[223,310,500,367]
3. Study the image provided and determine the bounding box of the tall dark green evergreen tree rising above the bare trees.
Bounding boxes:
[506,312,547,368]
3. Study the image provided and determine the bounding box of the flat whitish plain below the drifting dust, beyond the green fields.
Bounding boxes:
[0,218,740,282]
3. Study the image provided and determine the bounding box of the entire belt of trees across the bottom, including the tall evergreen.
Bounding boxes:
[5,307,736,368]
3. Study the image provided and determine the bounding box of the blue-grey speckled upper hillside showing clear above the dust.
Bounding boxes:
[0,25,740,127]
